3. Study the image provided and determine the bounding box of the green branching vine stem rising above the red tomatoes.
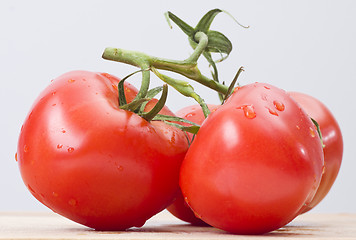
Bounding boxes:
[102,9,249,120]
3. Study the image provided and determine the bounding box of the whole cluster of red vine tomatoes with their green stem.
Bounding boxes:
[16,9,343,234]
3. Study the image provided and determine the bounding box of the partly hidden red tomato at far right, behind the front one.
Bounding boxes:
[289,92,343,212]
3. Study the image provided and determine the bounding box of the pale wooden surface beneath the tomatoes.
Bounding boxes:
[0,212,356,240]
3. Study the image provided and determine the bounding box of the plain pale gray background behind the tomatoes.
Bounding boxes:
[0,0,356,213]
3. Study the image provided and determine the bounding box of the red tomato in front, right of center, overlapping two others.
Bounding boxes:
[180,83,324,234]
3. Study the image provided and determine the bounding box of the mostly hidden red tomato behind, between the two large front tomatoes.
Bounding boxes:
[167,104,220,226]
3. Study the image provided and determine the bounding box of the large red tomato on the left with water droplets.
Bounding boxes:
[17,71,188,230]
